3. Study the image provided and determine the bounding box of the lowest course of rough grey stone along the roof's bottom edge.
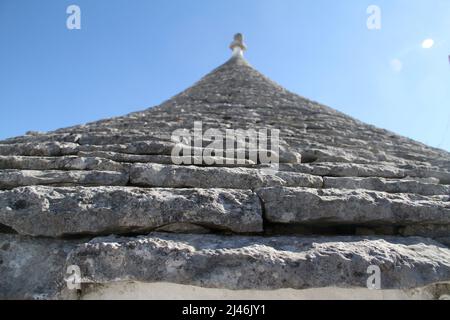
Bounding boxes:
[0,233,450,299]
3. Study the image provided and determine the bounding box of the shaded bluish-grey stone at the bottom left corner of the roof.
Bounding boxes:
[0,234,79,300]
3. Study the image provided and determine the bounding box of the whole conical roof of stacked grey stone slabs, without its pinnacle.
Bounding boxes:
[0,35,450,298]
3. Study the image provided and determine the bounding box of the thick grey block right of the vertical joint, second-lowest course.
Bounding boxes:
[258,187,450,231]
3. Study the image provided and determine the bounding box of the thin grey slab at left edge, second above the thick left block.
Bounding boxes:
[0,156,124,171]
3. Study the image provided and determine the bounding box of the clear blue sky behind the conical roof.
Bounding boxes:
[0,0,450,150]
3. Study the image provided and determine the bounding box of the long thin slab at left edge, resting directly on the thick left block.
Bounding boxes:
[0,170,128,189]
